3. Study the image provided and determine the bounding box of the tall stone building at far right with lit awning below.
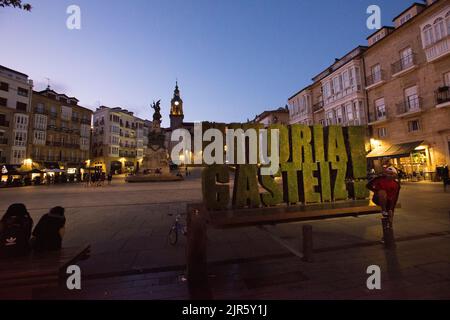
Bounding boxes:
[364,0,450,179]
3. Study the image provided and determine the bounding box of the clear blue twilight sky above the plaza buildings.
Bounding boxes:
[0,0,412,126]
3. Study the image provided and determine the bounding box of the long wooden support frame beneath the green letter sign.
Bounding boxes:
[186,200,394,299]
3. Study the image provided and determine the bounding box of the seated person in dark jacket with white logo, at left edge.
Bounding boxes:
[0,203,33,258]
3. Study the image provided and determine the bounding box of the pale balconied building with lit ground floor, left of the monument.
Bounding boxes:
[91,106,145,174]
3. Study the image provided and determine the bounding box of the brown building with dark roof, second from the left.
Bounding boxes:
[29,87,92,174]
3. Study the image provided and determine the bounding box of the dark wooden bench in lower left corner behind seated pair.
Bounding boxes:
[0,245,90,292]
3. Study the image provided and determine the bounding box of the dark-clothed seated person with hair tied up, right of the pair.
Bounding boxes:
[32,206,66,251]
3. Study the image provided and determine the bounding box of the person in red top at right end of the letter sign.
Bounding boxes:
[367,166,400,228]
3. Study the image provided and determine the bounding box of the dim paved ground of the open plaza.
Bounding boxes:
[0,173,450,299]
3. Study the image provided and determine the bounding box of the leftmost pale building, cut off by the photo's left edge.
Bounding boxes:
[0,66,33,165]
